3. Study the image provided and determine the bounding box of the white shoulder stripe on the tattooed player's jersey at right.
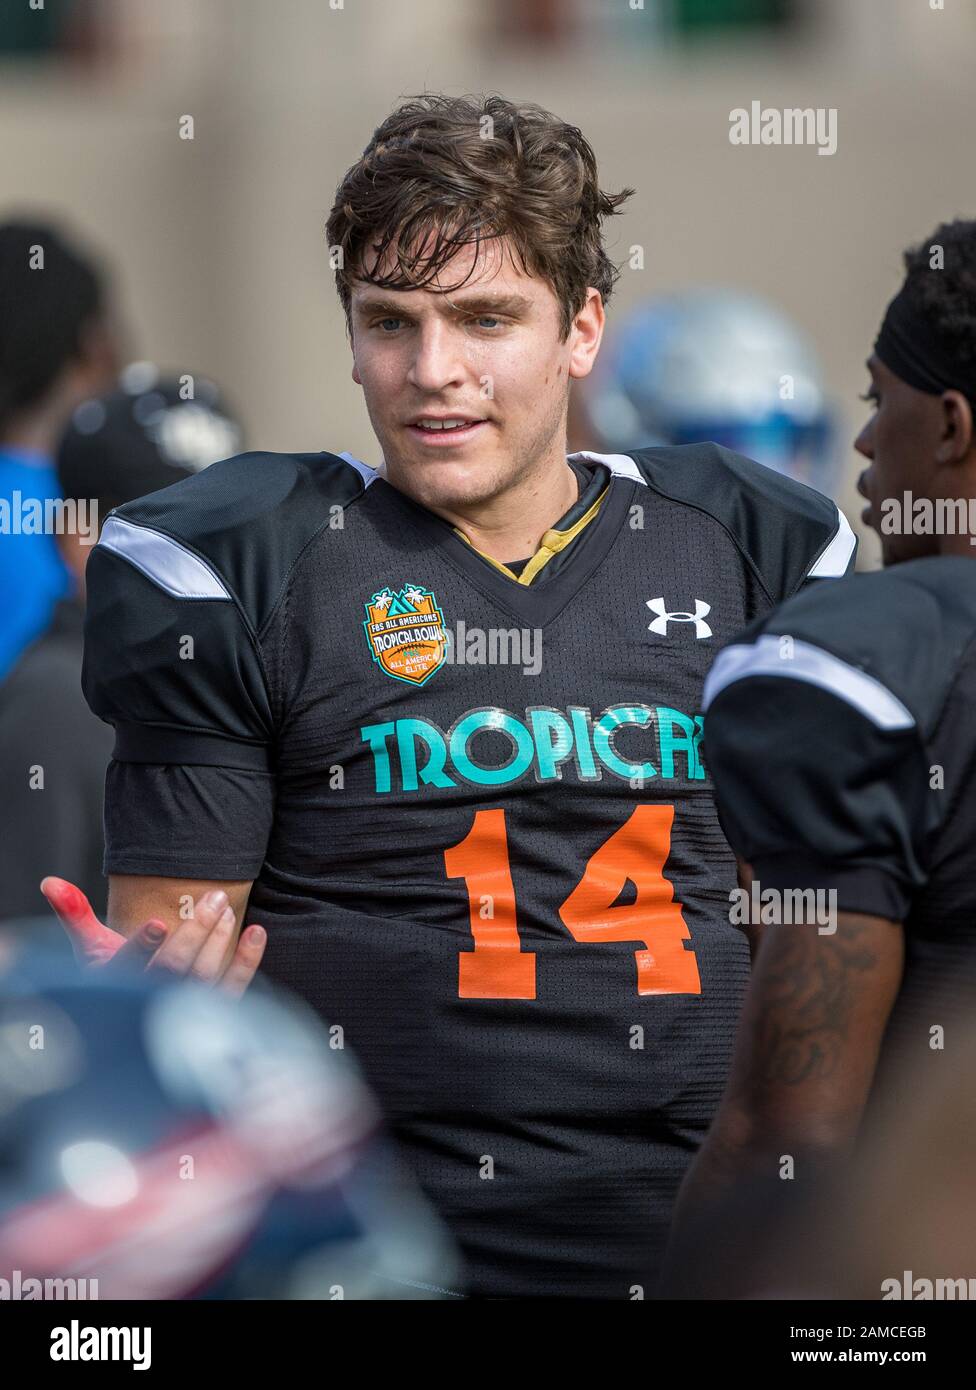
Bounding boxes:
[702,632,915,737]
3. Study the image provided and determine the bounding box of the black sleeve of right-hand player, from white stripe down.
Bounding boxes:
[703,635,930,922]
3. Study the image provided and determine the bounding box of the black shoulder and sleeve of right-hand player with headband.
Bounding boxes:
[703,560,976,922]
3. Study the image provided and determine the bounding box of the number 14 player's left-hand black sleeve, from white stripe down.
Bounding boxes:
[82,516,274,880]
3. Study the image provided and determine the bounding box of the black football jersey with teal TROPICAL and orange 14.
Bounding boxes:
[83,445,855,1298]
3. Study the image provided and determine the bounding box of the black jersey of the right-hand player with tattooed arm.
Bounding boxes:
[705,557,976,1108]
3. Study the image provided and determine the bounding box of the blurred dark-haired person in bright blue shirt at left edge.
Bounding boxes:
[0,221,118,680]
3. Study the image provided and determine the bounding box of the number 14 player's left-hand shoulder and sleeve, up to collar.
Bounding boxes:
[82,453,377,880]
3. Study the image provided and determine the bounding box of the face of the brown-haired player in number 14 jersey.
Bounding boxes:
[344,240,603,512]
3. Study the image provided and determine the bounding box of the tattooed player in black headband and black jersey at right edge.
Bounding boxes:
[669,214,976,1294]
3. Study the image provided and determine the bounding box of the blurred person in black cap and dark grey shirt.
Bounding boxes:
[0,363,242,920]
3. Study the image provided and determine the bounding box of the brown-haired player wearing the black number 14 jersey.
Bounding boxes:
[42,96,855,1298]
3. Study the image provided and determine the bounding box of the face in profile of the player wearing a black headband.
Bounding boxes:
[854,354,951,564]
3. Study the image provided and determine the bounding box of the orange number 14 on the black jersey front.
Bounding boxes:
[444,806,702,999]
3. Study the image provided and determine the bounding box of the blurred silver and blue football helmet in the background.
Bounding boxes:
[570,289,840,496]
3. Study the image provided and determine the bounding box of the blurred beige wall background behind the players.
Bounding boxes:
[0,0,976,566]
